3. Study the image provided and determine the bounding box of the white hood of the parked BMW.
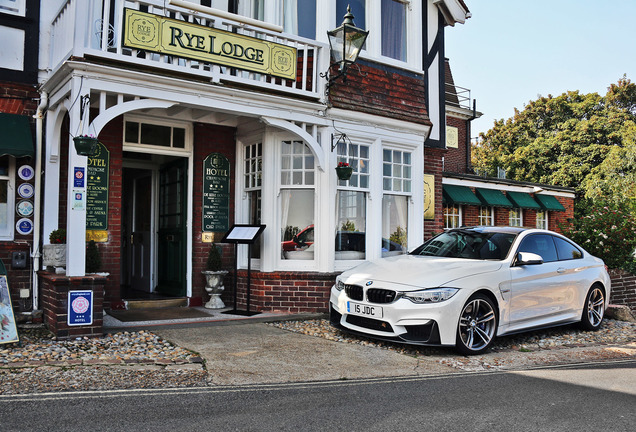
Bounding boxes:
[341,255,502,291]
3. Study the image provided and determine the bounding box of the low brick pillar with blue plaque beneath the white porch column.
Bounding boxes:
[38,271,108,339]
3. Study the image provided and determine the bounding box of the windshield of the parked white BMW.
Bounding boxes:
[411,230,516,260]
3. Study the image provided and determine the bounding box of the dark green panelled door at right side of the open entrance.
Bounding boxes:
[157,158,187,297]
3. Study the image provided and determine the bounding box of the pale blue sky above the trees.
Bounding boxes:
[445,0,636,138]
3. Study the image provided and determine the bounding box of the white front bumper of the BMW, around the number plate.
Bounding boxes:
[329,287,468,346]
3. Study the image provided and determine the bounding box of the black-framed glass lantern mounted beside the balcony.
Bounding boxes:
[320,6,369,90]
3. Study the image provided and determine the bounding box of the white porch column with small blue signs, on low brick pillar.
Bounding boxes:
[66,78,89,276]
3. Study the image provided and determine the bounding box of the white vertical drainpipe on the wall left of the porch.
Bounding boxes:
[31,91,49,310]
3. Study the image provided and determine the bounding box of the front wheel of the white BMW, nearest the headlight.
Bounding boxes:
[455,294,497,355]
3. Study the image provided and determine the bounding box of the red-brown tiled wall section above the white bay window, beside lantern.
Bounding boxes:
[329,61,431,125]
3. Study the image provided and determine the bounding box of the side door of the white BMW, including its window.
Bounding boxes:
[508,234,574,331]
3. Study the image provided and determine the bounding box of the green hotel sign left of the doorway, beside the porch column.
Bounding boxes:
[86,143,110,230]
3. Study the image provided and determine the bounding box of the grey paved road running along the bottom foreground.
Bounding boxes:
[0,360,636,432]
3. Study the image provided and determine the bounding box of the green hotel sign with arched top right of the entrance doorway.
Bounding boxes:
[203,153,230,232]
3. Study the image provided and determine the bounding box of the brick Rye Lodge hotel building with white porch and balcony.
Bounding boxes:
[0,0,573,324]
